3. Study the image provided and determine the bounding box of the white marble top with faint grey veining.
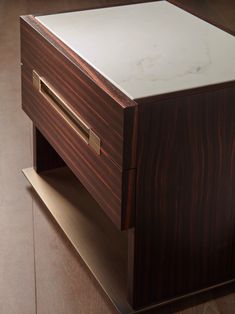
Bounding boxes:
[37,1,235,99]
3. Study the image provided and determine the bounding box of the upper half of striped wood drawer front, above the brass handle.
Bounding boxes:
[21,17,136,169]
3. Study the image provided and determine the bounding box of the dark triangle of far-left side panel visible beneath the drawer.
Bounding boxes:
[33,126,65,173]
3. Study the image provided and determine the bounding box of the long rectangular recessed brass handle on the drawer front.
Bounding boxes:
[33,70,100,155]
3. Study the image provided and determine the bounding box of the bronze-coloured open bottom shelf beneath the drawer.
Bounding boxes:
[23,167,133,314]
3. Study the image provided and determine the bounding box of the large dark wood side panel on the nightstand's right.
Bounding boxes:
[130,87,235,307]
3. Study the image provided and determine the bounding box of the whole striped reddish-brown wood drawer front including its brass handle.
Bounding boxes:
[21,17,136,229]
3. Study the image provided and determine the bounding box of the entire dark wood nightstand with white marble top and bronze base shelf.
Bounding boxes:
[21,1,235,313]
